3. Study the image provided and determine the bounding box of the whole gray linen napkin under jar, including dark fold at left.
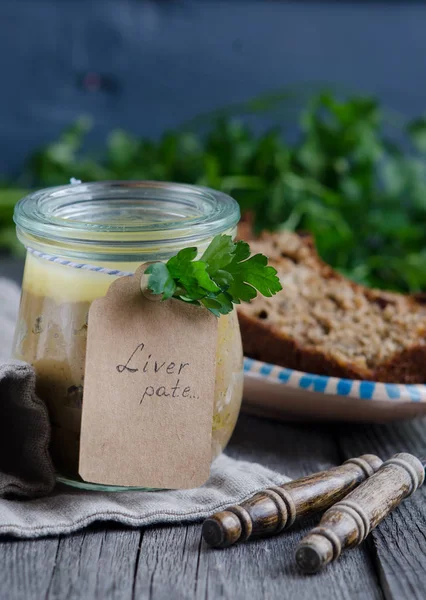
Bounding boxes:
[0,279,287,538]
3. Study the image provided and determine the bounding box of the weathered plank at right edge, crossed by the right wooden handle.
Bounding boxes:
[337,420,426,600]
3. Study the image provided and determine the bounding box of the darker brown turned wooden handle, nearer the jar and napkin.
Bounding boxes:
[203,454,382,548]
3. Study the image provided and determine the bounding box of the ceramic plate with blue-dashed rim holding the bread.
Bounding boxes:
[243,358,426,423]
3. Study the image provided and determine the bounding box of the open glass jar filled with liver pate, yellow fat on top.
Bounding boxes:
[14,181,243,488]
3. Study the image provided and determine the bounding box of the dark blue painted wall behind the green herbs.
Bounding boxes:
[0,0,426,173]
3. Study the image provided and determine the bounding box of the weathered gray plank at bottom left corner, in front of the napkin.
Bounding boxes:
[0,526,143,600]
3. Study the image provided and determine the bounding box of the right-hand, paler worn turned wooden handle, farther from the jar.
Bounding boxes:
[296,453,425,573]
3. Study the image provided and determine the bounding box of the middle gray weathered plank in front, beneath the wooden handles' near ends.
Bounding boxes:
[135,523,382,600]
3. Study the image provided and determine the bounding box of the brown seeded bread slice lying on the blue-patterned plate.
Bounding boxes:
[238,232,426,383]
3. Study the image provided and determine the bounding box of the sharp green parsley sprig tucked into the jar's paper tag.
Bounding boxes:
[146,235,282,317]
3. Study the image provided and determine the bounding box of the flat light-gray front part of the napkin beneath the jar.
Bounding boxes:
[0,455,286,538]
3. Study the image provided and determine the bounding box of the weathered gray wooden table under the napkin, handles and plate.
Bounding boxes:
[0,261,426,600]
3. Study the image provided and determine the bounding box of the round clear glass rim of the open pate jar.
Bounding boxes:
[14,181,240,260]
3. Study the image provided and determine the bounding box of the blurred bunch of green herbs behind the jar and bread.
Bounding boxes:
[0,93,426,292]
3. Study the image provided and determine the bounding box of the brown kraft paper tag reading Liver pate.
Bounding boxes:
[79,267,217,489]
